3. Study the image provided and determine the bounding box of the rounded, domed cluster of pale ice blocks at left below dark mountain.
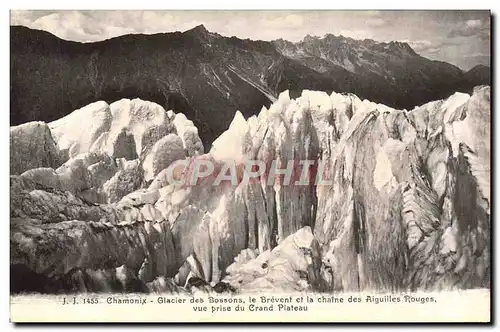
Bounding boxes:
[18,99,203,204]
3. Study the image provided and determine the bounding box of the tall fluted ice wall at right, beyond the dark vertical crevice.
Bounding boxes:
[315,87,490,291]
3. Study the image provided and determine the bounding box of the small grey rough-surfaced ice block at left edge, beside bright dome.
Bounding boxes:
[9,122,62,174]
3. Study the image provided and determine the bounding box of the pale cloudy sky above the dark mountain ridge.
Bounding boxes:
[11,10,490,69]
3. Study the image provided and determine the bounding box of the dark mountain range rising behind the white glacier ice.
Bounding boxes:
[10,26,490,147]
